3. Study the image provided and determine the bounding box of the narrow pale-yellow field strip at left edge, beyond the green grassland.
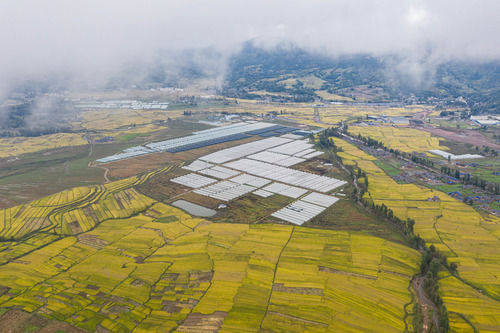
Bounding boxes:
[0,133,88,158]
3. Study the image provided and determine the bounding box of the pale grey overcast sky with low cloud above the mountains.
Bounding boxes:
[0,0,500,93]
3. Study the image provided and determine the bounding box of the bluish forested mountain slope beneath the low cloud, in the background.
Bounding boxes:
[224,43,500,112]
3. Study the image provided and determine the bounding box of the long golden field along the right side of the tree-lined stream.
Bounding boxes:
[335,139,500,331]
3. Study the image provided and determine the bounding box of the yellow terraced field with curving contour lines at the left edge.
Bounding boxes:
[0,167,170,240]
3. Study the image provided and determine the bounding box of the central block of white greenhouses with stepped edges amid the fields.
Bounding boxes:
[172,134,346,224]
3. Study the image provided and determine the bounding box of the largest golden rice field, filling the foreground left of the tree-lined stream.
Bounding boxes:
[0,191,420,332]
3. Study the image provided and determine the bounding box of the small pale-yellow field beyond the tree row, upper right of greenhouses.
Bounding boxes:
[349,126,448,153]
